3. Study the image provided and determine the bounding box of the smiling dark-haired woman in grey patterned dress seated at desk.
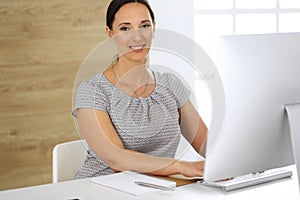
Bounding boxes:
[73,0,207,178]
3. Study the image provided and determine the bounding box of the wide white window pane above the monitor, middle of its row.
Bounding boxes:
[236,14,276,34]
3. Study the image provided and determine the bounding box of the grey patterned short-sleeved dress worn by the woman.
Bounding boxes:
[73,72,190,178]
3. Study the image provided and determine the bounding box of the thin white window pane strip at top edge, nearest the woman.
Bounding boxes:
[194,0,232,9]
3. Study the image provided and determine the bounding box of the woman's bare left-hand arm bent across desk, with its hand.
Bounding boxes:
[78,108,203,176]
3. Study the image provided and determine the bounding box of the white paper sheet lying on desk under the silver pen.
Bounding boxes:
[91,171,176,195]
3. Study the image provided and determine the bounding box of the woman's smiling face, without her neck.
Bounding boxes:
[107,3,155,62]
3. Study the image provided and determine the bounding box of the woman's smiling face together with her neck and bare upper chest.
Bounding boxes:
[104,2,155,97]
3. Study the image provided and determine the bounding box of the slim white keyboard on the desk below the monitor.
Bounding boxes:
[198,169,293,192]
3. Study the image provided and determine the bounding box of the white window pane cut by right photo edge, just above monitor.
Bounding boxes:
[279,13,300,32]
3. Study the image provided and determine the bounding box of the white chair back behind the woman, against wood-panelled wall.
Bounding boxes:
[52,140,87,183]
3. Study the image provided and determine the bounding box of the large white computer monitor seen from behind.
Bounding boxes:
[204,33,300,186]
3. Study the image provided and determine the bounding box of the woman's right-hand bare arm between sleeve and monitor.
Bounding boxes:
[179,100,207,157]
